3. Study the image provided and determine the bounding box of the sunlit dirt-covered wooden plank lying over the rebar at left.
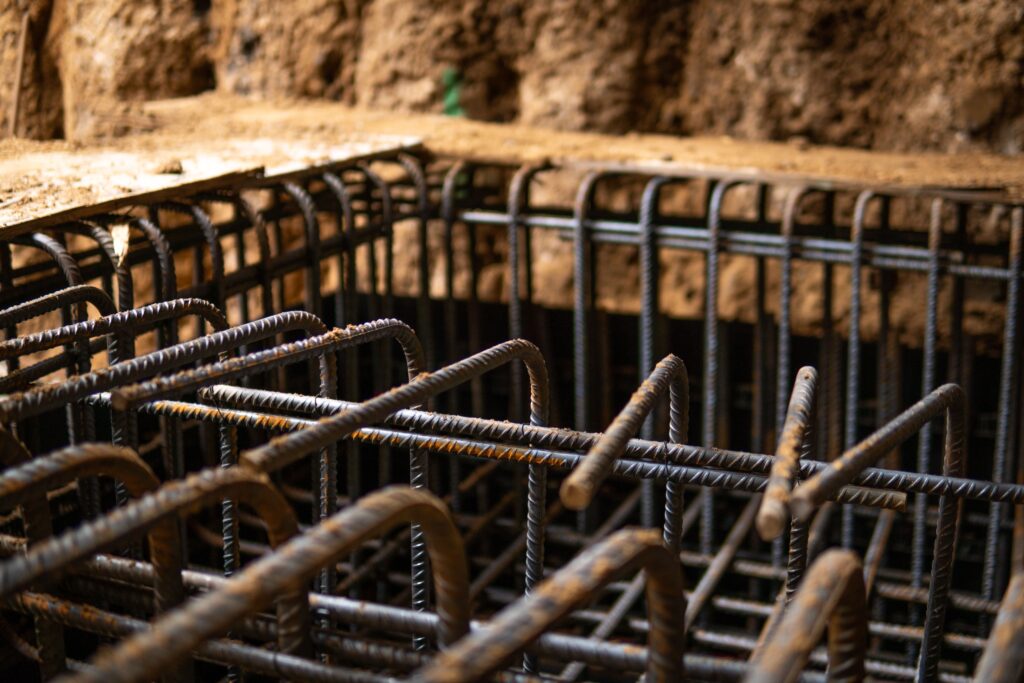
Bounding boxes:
[0,133,418,237]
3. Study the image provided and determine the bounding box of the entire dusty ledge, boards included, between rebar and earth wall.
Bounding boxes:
[0,94,1024,229]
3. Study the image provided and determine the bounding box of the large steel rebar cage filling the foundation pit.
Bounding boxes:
[0,145,1024,682]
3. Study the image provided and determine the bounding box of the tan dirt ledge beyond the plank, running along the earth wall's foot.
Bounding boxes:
[140,95,1024,197]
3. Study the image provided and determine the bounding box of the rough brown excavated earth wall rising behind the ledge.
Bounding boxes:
[0,0,1024,154]
